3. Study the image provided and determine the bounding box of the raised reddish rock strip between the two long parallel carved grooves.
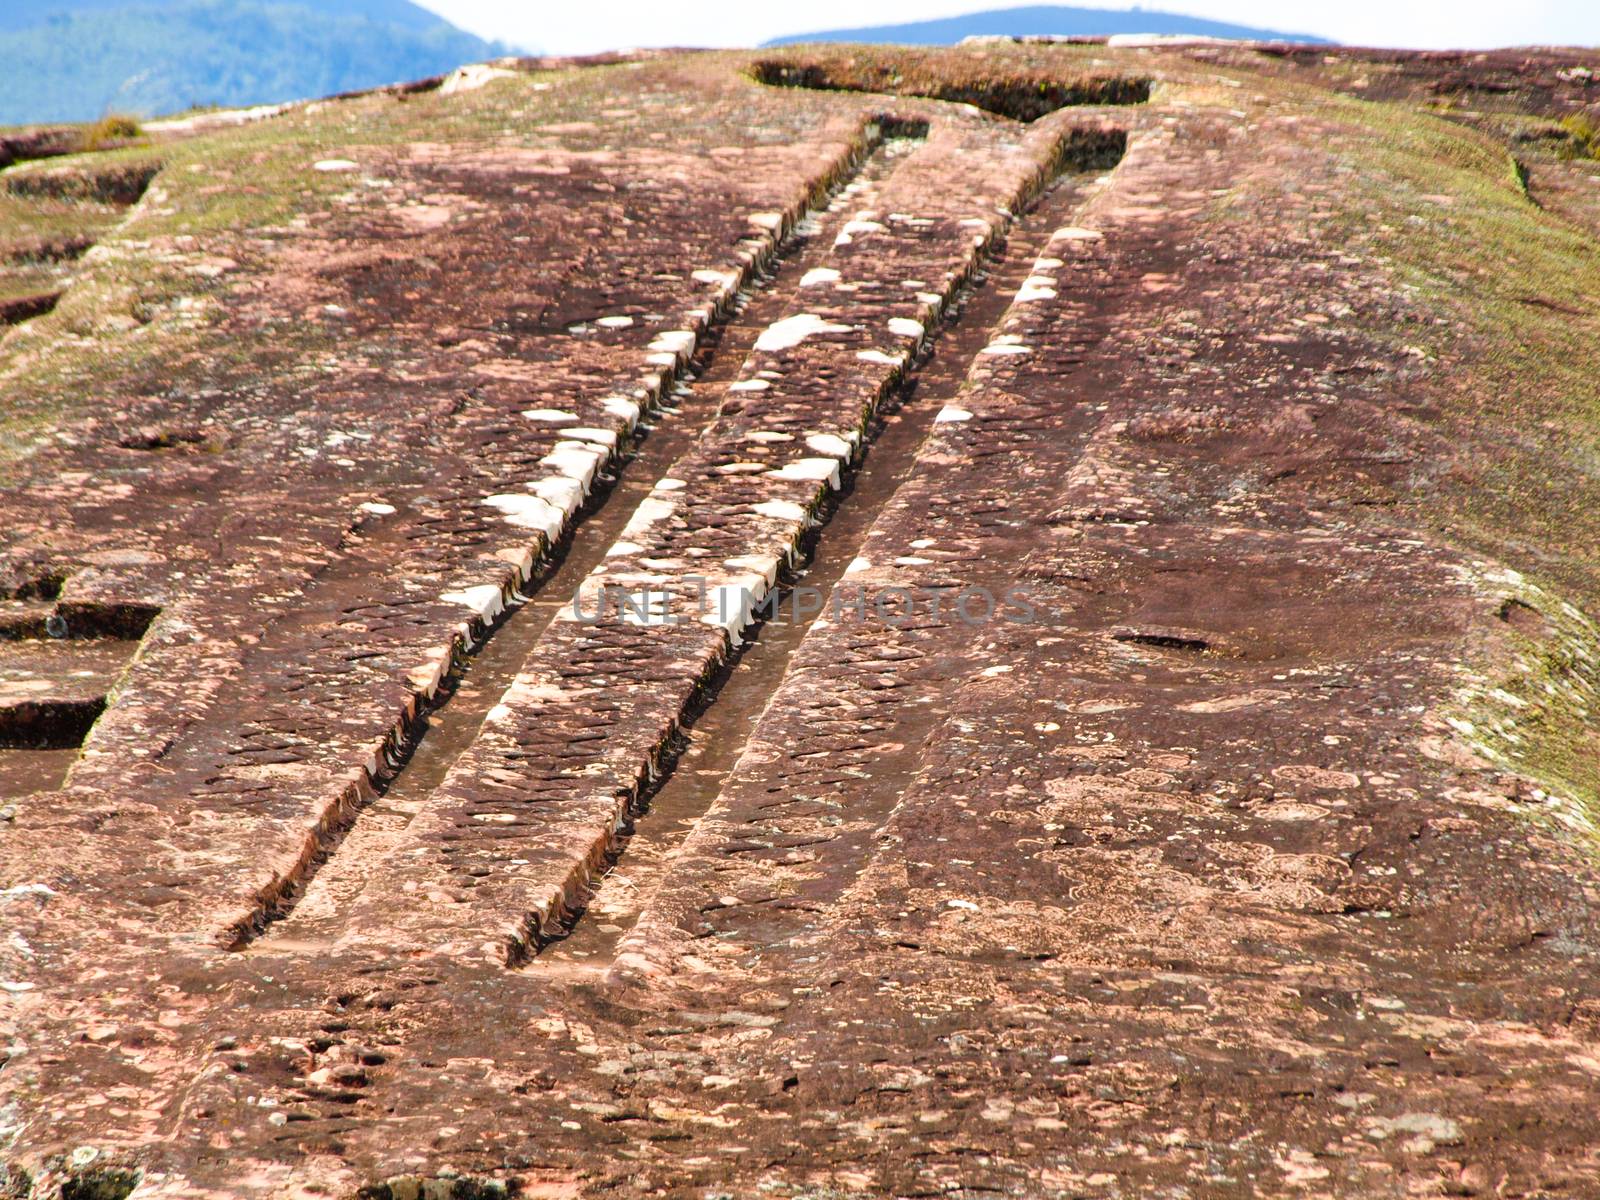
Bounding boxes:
[240,115,1125,963]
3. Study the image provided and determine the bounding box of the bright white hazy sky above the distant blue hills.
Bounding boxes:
[418,0,1600,54]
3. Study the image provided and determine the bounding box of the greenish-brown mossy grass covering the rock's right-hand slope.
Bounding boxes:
[1196,65,1600,824]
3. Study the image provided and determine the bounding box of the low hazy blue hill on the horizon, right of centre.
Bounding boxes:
[766,5,1326,46]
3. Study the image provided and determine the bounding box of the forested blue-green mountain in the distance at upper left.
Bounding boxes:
[0,0,509,125]
